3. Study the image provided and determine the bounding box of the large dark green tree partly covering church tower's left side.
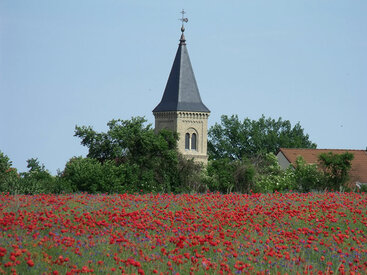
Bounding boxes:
[75,117,203,192]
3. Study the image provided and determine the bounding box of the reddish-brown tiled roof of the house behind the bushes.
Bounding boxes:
[279,148,367,183]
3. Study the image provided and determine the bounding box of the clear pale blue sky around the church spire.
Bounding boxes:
[0,0,367,174]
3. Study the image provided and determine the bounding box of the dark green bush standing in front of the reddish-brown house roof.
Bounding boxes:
[319,152,354,191]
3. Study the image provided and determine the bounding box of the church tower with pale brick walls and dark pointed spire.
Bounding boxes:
[153,11,210,164]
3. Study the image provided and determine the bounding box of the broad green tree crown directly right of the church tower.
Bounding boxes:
[208,115,316,160]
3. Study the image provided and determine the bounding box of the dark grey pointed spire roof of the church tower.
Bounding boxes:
[153,28,210,112]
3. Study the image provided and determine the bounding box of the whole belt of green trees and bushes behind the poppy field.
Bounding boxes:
[0,115,360,194]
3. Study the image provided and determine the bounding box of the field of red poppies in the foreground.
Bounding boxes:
[0,192,367,274]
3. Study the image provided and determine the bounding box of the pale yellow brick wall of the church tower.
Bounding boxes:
[154,111,209,164]
